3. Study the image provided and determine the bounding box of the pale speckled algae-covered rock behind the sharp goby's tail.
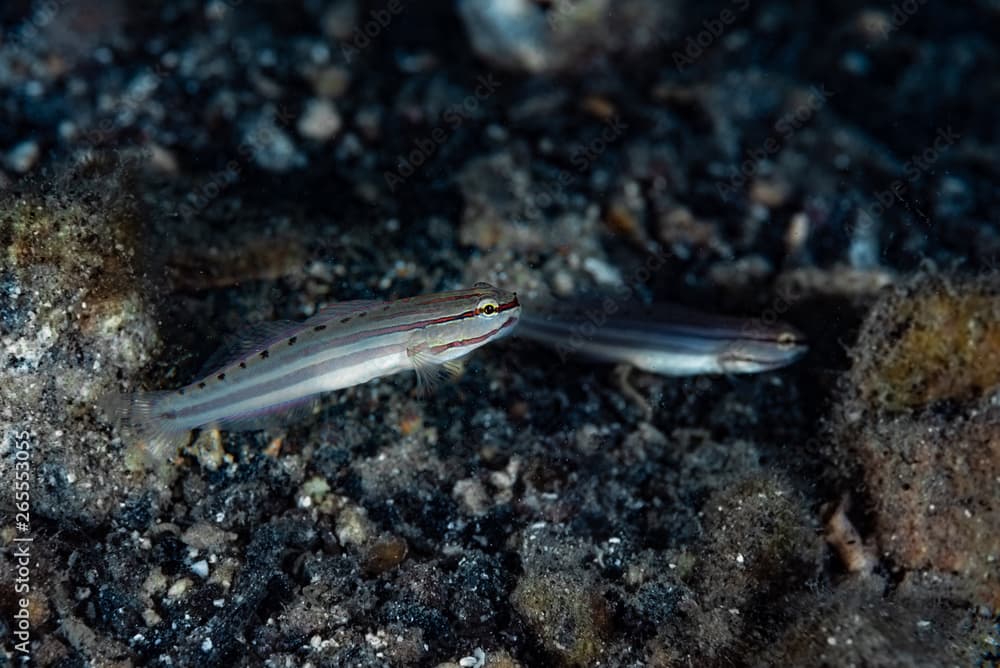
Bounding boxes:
[0,158,157,524]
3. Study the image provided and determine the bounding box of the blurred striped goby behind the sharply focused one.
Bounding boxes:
[517,299,808,376]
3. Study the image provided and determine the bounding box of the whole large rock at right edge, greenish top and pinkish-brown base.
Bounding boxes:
[833,276,1000,608]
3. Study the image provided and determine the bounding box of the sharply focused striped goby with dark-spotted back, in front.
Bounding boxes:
[102,283,521,462]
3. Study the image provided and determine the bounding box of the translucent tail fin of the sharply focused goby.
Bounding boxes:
[99,392,191,468]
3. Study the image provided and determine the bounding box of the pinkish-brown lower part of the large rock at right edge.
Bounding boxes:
[844,405,1000,607]
